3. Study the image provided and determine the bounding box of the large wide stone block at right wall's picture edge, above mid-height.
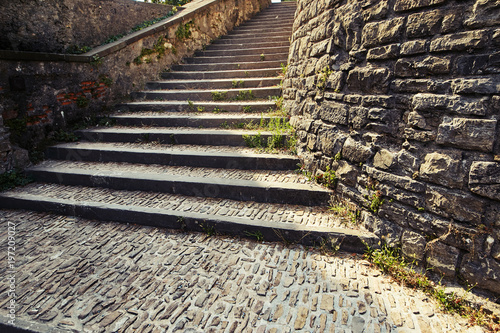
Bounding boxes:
[436,117,497,152]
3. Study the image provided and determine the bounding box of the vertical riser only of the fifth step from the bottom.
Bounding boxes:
[112,116,280,128]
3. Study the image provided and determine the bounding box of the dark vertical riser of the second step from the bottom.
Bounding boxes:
[28,170,330,206]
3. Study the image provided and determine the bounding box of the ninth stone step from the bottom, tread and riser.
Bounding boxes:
[161,67,282,80]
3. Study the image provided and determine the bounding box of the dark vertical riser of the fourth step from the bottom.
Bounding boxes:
[77,131,282,147]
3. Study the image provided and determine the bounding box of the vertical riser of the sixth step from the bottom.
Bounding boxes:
[116,102,276,113]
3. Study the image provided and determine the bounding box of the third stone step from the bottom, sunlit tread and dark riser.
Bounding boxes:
[46,142,300,170]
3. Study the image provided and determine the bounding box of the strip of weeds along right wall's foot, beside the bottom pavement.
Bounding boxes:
[364,244,500,332]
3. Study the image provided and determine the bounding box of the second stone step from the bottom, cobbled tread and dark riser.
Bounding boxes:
[26,160,331,206]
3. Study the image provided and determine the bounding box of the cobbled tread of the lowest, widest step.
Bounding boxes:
[0,183,369,232]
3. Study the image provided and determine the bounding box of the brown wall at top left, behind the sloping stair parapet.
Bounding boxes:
[0,0,171,53]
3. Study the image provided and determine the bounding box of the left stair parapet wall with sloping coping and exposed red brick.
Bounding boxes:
[0,0,270,173]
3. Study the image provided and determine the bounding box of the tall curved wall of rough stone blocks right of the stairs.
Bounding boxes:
[283,0,500,294]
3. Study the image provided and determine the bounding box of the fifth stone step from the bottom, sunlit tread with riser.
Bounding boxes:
[110,112,284,128]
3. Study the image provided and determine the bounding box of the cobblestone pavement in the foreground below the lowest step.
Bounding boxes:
[0,211,481,333]
